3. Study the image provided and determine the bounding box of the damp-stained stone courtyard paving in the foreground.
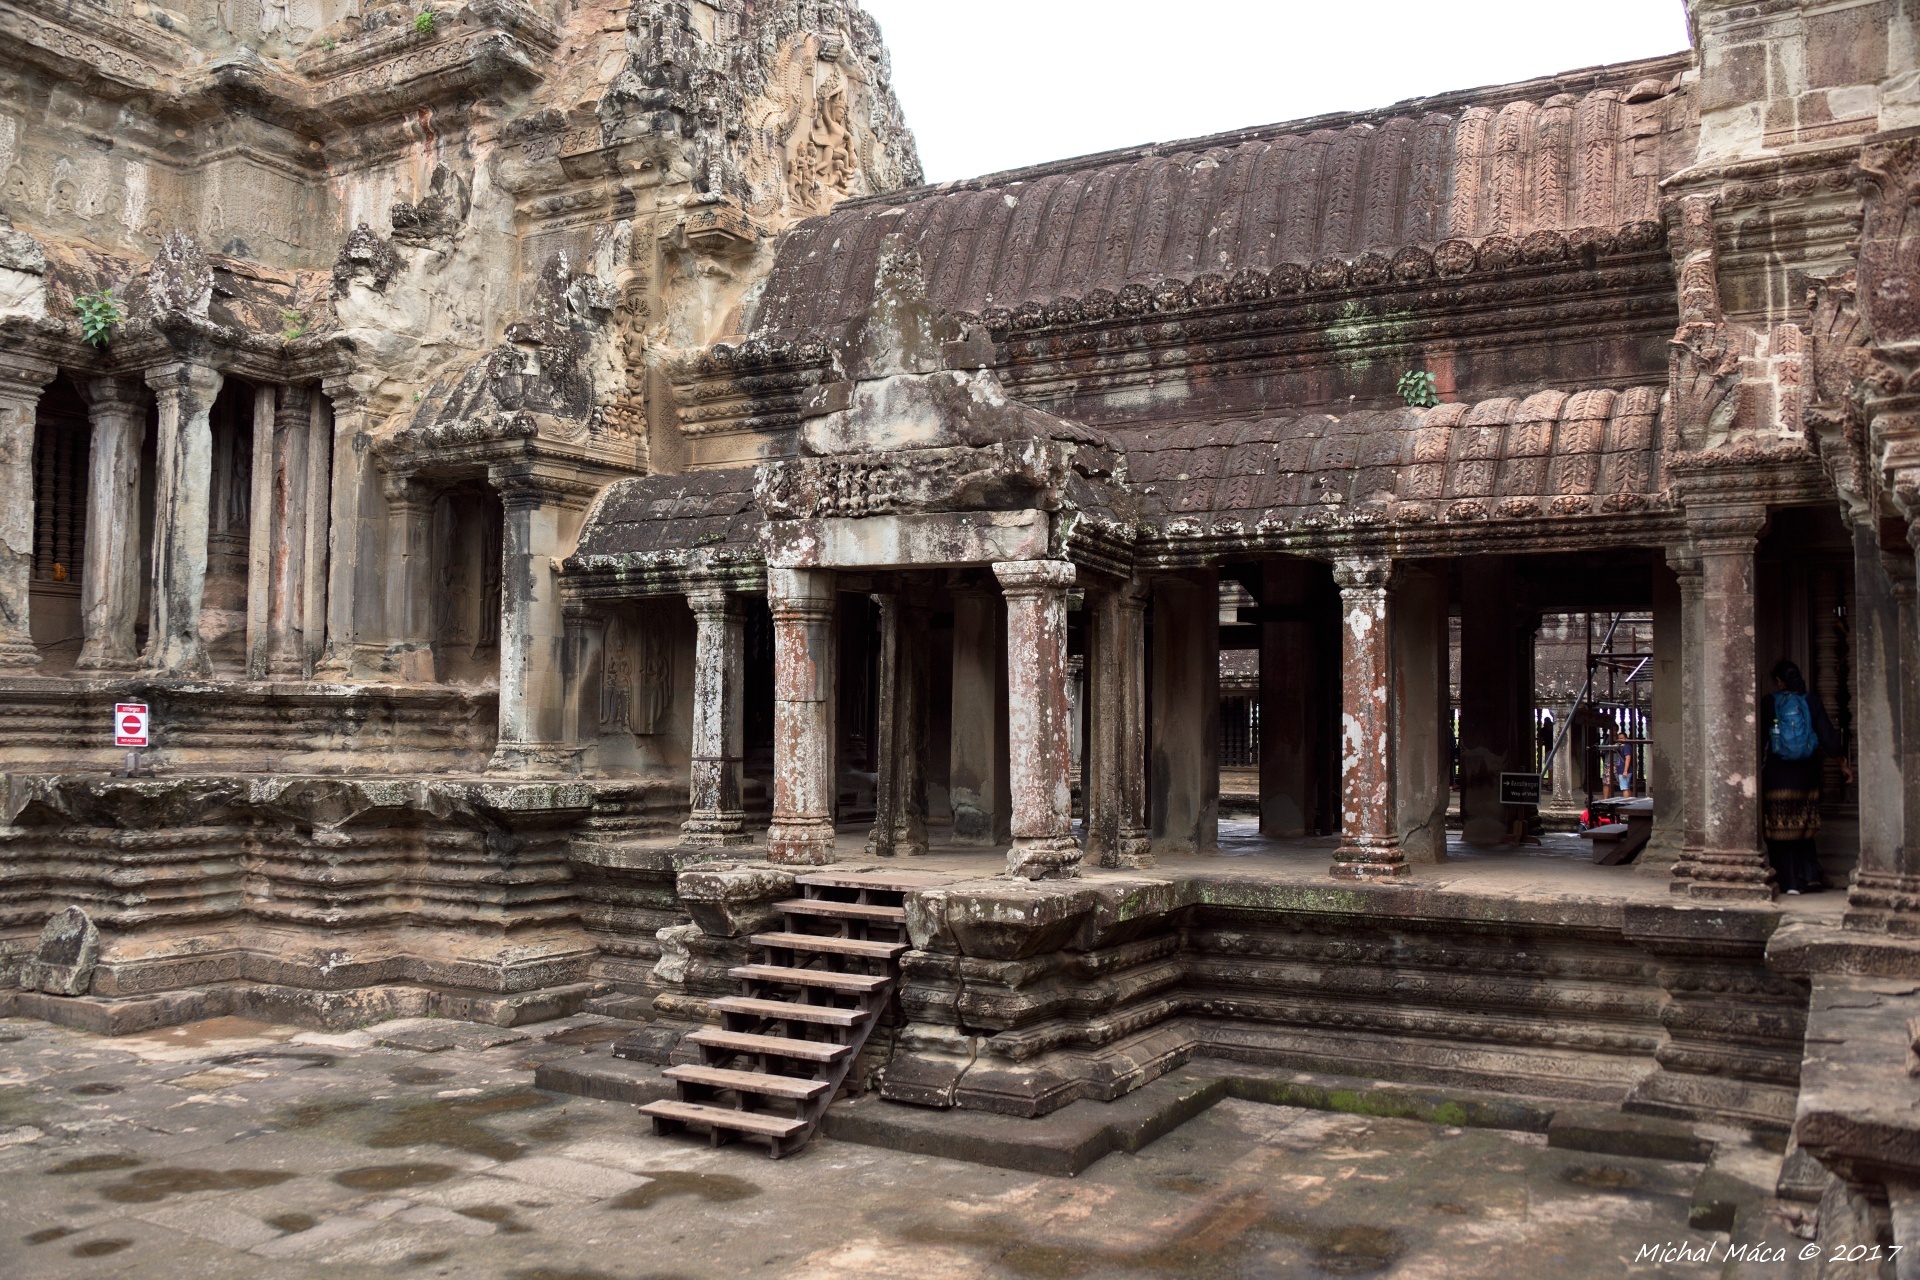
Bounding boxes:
[0,1017,1799,1280]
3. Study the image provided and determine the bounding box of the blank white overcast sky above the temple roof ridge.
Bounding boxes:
[862,0,1688,182]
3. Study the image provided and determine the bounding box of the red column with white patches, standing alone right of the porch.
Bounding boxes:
[1331,558,1407,881]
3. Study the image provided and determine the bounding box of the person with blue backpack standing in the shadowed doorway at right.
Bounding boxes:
[1761,658,1853,894]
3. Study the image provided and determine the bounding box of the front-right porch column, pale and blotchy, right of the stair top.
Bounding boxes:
[993,560,1081,881]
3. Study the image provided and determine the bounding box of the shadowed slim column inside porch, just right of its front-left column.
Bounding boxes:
[866,591,927,858]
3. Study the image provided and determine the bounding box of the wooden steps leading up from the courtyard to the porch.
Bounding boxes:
[641,871,910,1159]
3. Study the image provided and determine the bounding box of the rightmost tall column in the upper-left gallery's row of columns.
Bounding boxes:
[321,378,380,679]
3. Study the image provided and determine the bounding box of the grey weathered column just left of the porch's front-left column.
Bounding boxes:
[680,587,751,848]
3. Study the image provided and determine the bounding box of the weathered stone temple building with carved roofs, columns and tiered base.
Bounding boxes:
[0,0,1920,1276]
